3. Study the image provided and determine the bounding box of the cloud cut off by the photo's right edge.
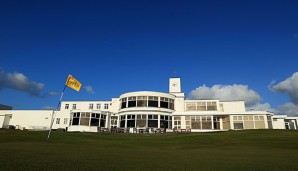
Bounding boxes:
[271,72,298,105]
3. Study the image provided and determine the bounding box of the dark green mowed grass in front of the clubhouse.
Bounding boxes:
[0,130,298,171]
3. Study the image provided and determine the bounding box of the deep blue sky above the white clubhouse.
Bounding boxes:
[0,0,298,115]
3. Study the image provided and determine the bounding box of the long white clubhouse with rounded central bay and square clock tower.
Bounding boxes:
[0,78,298,133]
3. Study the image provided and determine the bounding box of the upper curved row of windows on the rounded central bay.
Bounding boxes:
[120,96,174,110]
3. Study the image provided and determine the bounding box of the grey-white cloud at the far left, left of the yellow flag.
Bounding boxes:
[0,70,57,97]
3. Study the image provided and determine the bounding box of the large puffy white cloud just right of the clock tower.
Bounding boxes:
[190,84,261,106]
